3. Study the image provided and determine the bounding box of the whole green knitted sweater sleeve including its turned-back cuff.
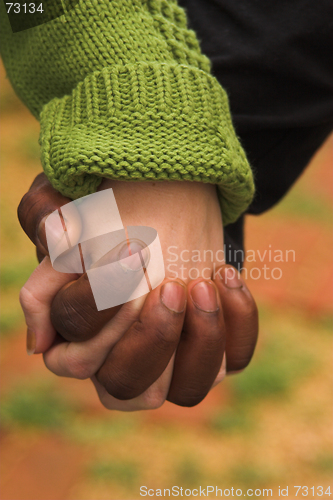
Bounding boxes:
[0,0,254,224]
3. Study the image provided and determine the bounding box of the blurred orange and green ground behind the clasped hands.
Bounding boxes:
[0,59,333,500]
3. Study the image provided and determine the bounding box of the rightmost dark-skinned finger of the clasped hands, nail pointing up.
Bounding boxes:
[215,265,259,372]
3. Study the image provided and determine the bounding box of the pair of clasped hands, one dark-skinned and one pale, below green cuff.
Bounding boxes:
[18,174,258,411]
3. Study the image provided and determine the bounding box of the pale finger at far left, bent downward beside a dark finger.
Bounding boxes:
[20,257,76,354]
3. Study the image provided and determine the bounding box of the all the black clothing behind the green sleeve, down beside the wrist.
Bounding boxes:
[178,0,333,267]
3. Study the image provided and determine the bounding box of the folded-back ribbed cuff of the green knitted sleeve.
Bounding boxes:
[40,62,254,225]
